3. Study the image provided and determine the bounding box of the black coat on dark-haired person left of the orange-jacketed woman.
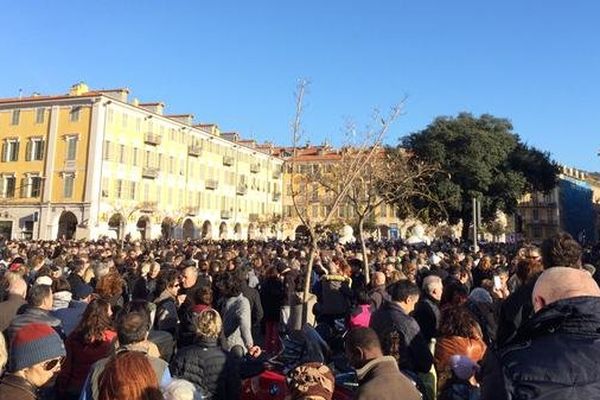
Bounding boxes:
[370,302,433,373]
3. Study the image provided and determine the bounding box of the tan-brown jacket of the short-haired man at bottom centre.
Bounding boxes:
[354,356,421,400]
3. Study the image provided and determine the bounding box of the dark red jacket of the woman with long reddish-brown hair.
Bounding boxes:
[56,330,117,397]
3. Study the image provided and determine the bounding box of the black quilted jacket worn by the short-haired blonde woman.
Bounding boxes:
[171,340,241,400]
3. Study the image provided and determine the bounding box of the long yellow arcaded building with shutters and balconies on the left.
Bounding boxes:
[0,84,283,239]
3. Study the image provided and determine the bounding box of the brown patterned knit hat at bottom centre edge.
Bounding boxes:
[288,362,335,400]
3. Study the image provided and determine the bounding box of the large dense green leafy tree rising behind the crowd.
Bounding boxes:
[401,113,559,238]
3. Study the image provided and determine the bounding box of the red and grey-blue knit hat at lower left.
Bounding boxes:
[9,323,67,372]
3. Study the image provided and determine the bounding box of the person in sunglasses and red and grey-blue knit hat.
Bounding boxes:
[0,323,66,400]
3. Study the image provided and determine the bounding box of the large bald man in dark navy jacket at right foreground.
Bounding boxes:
[482,267,600,400]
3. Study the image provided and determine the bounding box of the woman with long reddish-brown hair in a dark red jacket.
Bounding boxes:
[56,299,117,399]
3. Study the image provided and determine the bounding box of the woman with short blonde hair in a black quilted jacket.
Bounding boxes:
[171,308,241,400]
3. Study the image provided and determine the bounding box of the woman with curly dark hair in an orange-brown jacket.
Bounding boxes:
[434,305,487,387]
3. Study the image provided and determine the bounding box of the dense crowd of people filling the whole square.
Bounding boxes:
[0,233,600,400]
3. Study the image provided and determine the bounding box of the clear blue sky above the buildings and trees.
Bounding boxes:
[0,0,600,171]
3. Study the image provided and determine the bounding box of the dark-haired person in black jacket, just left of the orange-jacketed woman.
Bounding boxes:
[370,281,433,376]
